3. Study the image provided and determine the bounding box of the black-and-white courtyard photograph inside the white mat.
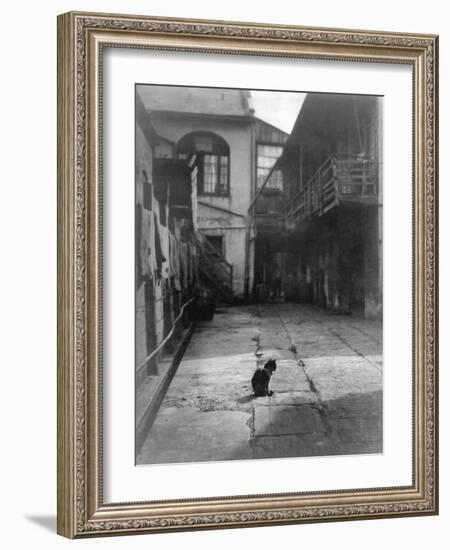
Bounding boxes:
[135,84,383,465]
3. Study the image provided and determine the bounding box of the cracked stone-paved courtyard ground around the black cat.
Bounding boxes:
[137,304,383,464]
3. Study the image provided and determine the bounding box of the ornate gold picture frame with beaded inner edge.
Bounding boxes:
[58,13,438,538]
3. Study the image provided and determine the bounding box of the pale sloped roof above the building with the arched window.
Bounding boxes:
[137,84,254,116]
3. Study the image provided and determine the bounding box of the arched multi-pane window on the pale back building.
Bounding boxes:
[177,132,230,196]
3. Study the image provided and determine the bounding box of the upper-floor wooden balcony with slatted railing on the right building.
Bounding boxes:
[286,155,378,224]
